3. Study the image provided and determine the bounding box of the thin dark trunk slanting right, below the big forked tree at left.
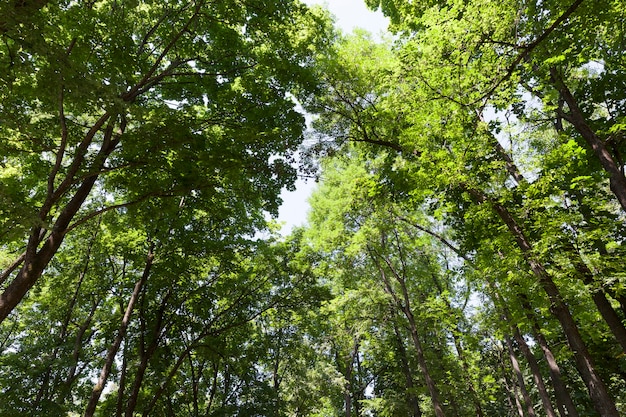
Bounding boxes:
[83,244,154,417]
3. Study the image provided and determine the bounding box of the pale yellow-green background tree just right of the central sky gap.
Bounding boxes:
[302,155,498,415]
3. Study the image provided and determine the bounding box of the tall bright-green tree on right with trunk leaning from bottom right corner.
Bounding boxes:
[300,11,624,415]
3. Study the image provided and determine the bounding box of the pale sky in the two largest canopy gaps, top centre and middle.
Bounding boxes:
[278,0,388,234]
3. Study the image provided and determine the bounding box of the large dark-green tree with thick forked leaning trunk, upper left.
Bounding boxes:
[0,0,328,320]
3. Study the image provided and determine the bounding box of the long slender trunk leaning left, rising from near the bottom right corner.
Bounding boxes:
[467,189,619,417]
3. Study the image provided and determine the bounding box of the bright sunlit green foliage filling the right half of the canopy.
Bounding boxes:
[294,1,625,415]
